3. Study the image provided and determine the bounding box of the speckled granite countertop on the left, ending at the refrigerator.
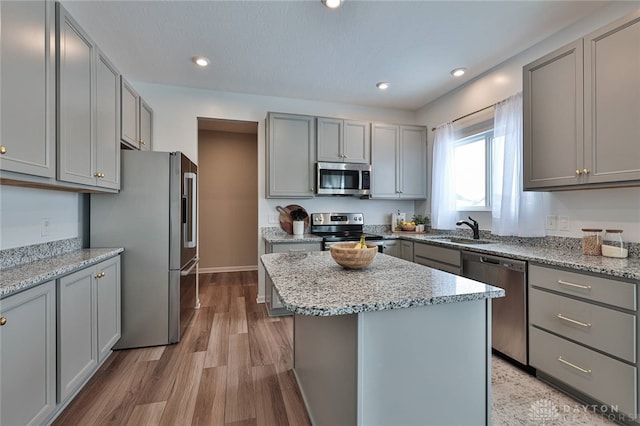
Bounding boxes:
[0,248,124,298]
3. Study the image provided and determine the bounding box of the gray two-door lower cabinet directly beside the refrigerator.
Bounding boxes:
[57,256,120,403]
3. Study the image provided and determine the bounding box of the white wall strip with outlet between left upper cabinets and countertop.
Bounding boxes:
[0,186,82,249]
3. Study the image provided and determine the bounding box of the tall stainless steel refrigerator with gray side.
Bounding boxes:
[90,150,198,349]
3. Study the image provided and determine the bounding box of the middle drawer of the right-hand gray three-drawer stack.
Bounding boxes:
[529,288,636,362]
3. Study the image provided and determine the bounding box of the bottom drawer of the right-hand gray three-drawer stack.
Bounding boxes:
[529,327,638,414]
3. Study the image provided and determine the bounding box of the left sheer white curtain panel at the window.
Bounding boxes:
[431,123,457,229]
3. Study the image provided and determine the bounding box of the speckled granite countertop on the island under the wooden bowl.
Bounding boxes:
[261,252,505,316]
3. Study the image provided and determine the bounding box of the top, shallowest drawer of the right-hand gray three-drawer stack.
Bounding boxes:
[529,265,637,311]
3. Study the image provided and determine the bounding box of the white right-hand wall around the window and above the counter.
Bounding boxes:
[416,1,640,242]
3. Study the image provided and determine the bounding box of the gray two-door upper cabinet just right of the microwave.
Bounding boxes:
[371,123,427,200]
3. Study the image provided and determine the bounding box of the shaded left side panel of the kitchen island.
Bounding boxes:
[293,314,358,426]
